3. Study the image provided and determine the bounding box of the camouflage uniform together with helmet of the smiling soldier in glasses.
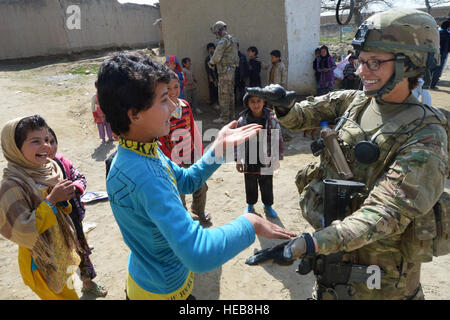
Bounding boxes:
[268,10,448,299]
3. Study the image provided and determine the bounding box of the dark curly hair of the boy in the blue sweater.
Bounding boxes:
[96,52,170,135]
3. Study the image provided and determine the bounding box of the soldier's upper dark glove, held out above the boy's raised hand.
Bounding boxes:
[245,84,296,116]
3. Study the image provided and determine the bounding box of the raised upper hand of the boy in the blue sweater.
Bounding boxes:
[212,120,262,157]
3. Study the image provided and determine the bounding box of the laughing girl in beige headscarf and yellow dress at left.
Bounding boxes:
[0,115,81,300]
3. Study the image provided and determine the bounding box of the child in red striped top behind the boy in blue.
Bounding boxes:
[159,72,211,222]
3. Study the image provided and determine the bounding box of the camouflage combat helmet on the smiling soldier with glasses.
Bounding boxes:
[352,9,440,97]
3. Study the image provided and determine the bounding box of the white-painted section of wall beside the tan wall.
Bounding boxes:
[285,0,320,94]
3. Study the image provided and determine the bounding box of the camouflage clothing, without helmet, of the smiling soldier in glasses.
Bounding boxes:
[279,90,448,299]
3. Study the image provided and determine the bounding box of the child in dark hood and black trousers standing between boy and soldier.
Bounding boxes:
[235,93,284,218]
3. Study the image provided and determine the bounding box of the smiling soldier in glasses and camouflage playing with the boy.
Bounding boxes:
[247,9,448,299]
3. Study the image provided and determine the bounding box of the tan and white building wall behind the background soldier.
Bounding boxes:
[160,0,320,101]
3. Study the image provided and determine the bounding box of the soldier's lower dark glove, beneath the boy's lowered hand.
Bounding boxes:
[245,233,315,266]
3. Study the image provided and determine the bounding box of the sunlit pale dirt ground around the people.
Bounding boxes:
[0,50,450,300]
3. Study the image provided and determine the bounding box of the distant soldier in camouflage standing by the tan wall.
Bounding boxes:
[209,21,239,124]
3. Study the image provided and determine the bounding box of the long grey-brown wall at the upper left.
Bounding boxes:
[0,0,160,60]
